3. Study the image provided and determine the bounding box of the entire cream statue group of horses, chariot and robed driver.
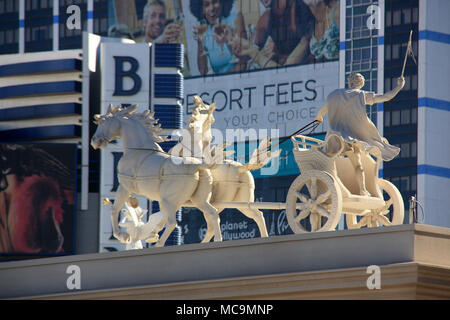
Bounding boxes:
[91,74,404,249]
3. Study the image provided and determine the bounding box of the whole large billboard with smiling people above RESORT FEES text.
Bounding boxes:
[109,0,340,137]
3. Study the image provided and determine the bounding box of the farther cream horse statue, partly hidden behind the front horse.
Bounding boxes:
[169,96,281,241]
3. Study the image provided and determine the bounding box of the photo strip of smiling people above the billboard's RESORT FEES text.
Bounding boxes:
[109,0,339,78]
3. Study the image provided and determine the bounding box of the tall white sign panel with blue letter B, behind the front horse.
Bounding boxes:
[100,43,151,252]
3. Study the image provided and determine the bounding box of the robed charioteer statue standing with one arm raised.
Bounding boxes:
[315,72,405,195]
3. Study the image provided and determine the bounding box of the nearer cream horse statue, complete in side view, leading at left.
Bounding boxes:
[91,105,222,246]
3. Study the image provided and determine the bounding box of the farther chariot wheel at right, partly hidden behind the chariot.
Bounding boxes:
[345,179,405,229]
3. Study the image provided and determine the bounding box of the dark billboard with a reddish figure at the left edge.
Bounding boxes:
[0,143,77,254]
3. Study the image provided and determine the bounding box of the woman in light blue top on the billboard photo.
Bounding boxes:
[189,0,247,75]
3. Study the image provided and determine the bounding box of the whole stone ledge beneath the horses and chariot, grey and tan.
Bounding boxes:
[0,224,450,299]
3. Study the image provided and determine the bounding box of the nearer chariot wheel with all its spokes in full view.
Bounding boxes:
[286,170,342,233]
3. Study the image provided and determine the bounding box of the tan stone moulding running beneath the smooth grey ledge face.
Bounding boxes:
[20,262,450,300]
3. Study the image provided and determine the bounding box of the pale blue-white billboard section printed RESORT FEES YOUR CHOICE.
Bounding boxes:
[184,61,339,137]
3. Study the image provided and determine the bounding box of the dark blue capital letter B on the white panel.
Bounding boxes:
[113,56,142,96]
